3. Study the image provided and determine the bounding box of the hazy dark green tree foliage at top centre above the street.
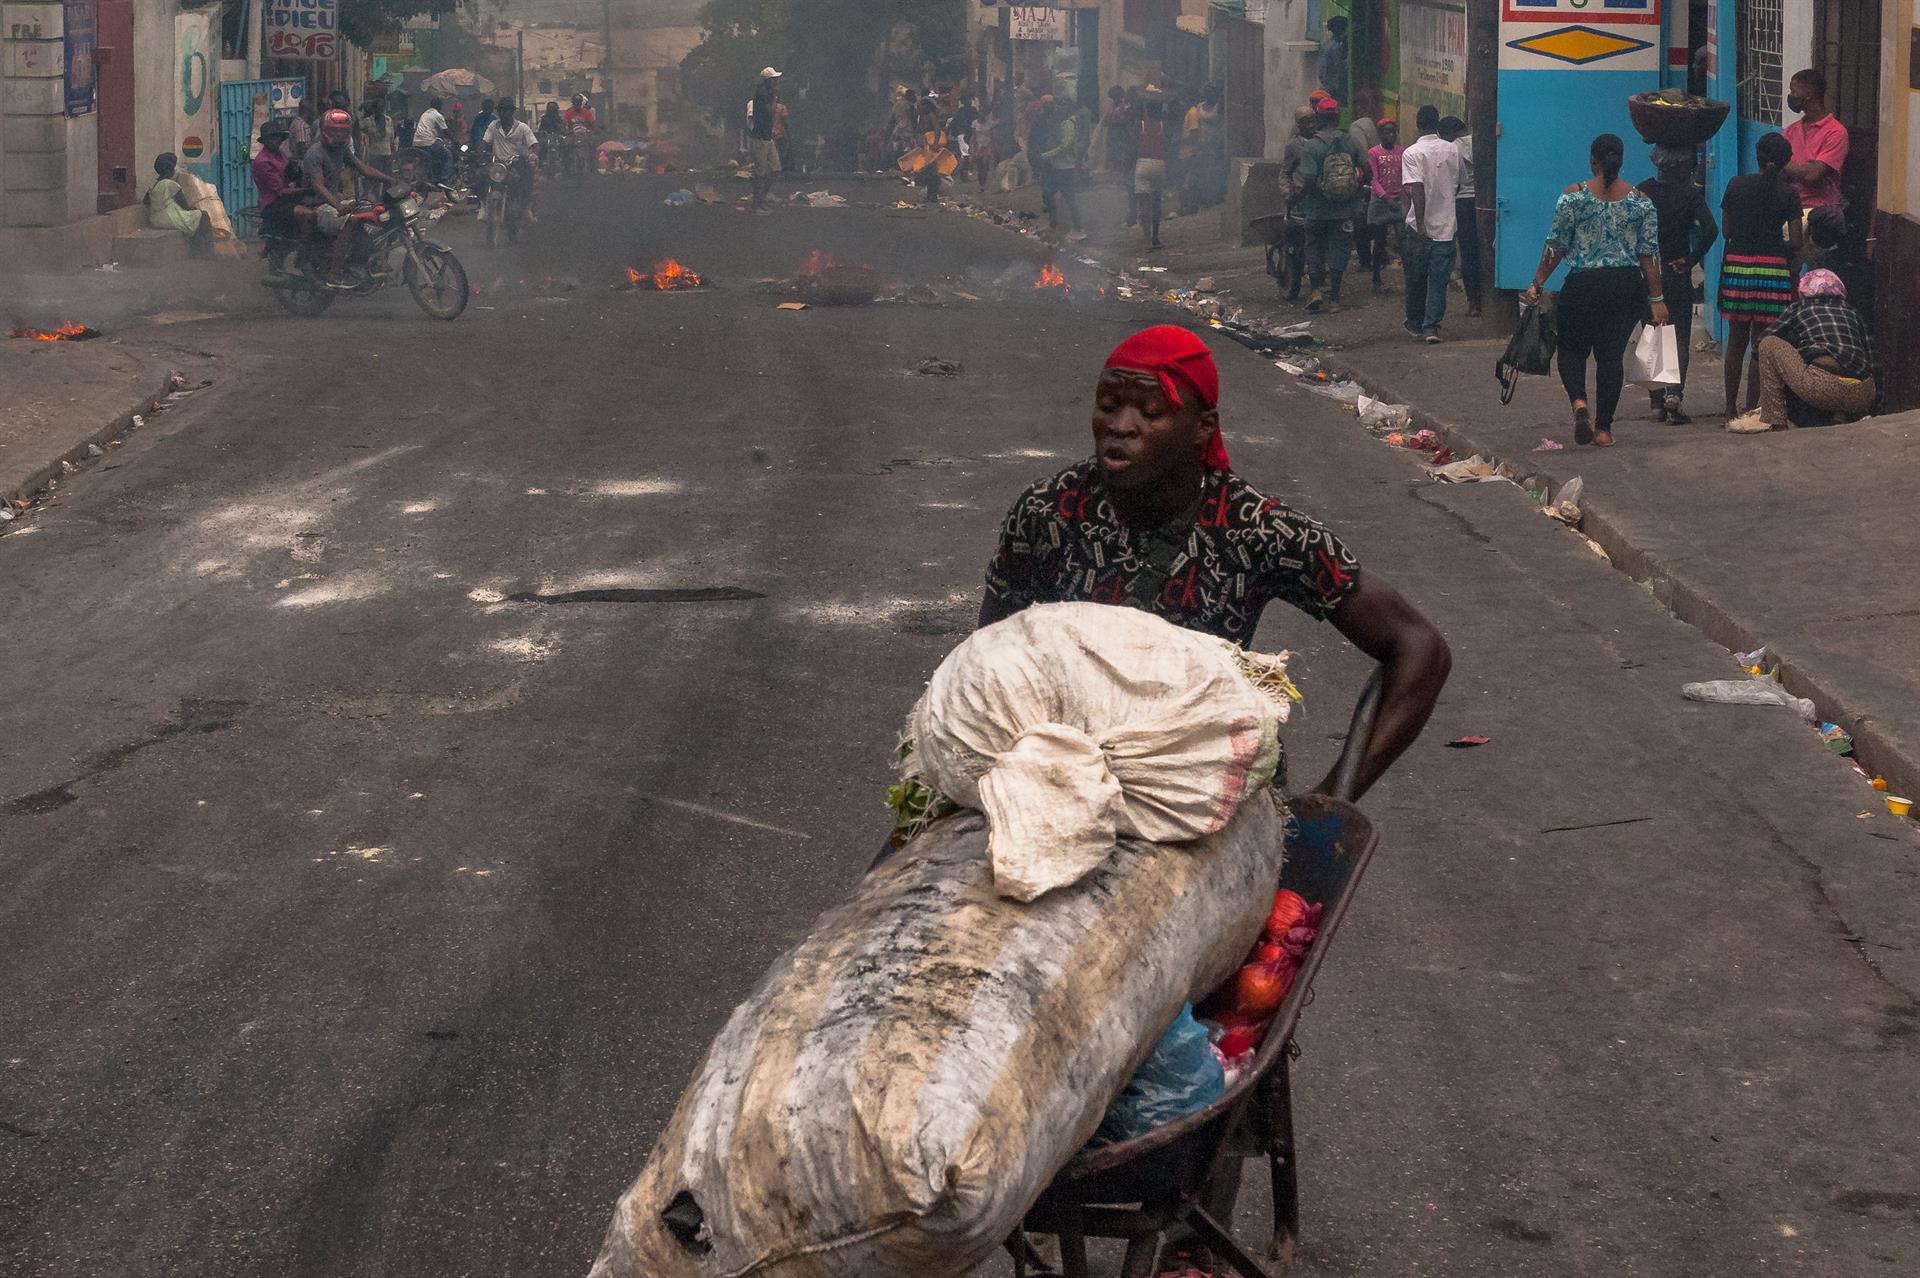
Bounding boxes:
[682,0,968,129]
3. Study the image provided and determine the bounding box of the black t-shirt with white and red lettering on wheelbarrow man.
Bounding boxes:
[987,461,1359,647]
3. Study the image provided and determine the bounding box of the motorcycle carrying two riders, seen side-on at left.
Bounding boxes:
[261,182,468,320]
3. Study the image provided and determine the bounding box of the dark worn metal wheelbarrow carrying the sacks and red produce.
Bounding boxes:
[1006,670,1384,1278]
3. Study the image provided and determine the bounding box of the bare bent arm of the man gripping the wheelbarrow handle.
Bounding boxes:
[1313,572,1453,798]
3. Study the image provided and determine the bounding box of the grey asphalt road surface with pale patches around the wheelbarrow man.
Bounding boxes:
[0,178,1920,1276]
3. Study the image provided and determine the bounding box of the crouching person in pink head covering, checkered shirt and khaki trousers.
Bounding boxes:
[1726,271,1878,436]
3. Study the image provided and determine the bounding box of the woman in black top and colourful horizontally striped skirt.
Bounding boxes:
[1720,132,1801,420]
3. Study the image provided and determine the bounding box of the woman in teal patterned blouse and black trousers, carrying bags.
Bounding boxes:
[1521,132,1667,449]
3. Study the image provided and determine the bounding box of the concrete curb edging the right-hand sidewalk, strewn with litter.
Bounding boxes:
[1319,355,1920,794]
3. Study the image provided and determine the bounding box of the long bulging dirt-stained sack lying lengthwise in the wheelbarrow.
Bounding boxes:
[591,791,1284,1278]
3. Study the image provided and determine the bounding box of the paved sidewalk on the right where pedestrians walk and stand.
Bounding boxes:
[958,168,1920,806]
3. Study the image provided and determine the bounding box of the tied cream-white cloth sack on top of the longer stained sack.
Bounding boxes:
[902,603,1288,900]
